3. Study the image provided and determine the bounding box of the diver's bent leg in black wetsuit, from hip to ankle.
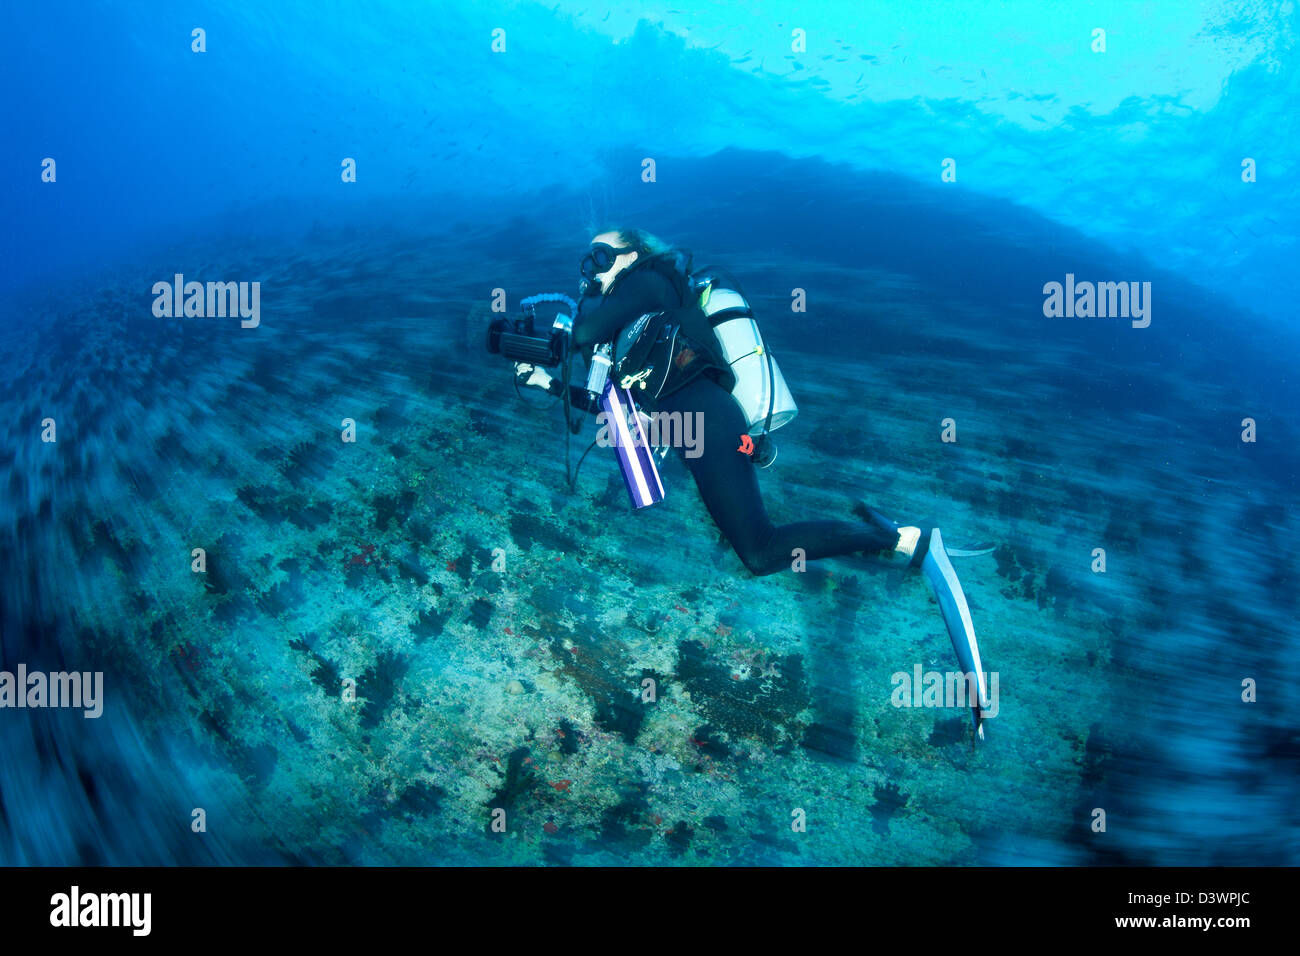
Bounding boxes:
[658,378,898,575]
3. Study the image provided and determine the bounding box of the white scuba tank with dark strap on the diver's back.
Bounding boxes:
[690,273,800,437]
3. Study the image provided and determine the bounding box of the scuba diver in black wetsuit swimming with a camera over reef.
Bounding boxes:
[501,229,992,737]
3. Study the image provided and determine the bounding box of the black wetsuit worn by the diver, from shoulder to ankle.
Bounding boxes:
[546,258,898,575]
